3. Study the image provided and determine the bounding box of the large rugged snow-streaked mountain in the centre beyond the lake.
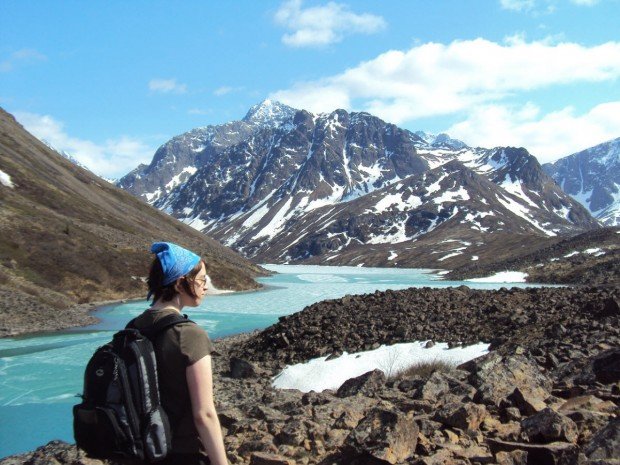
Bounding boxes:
[119,101,598,266]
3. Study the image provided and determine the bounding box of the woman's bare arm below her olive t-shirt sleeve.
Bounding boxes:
[185,355,228,465]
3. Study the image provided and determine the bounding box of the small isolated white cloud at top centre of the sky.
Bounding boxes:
[275,0,386,47]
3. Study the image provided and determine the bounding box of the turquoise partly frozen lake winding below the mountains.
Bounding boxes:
[0,265,540,458]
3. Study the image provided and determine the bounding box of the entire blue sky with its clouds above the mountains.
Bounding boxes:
[0,0,620,177]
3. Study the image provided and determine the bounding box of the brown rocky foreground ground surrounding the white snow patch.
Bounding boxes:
[0,288,620,465]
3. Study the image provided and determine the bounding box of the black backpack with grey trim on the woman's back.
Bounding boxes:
[73,313,193,462]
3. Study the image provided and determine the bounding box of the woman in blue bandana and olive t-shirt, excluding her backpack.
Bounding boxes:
[134,242,228,465]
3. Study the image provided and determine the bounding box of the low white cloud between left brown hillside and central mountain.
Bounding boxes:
[15,112,155,178]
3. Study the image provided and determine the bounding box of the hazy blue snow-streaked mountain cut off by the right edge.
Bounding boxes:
[543,137,620,226]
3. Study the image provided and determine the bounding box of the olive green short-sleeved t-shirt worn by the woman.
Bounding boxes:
[134,309,213,453]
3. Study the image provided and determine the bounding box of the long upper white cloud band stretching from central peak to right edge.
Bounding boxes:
[270,37,620,119]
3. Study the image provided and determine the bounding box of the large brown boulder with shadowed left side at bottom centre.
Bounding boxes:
[344,408,419,465]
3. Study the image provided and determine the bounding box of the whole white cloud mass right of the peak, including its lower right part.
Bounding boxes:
[269,36,620,160]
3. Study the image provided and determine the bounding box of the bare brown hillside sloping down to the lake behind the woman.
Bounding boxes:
[0,109,264,335]
